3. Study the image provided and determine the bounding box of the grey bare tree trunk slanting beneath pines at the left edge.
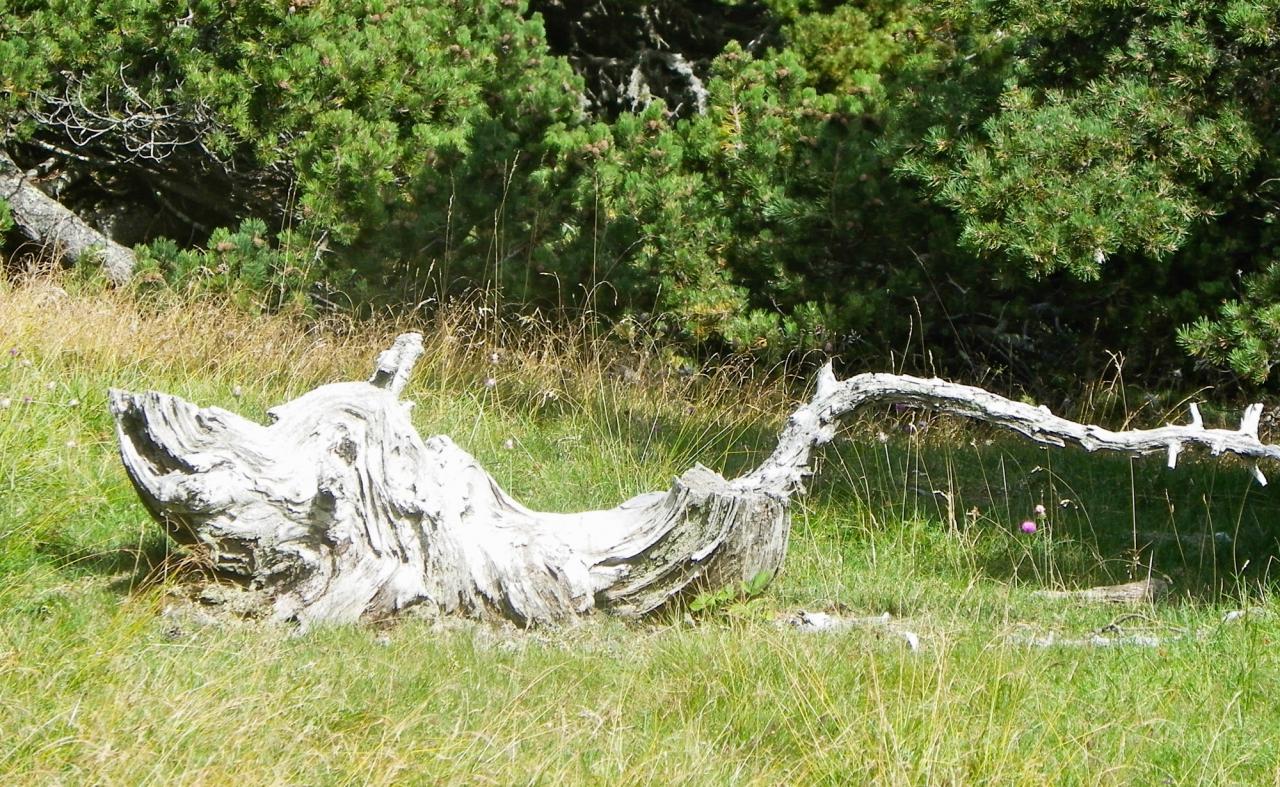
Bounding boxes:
[0,150,136,284]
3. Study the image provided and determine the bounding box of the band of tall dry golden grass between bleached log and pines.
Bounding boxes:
[0,275,786,429]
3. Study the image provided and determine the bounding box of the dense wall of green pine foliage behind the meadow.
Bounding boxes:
[0,0,1280,384]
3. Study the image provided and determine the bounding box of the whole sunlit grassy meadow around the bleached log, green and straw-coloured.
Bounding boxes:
[0,275,1280,784]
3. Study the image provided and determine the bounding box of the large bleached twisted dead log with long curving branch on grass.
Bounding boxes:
[110,334,1280,626]
